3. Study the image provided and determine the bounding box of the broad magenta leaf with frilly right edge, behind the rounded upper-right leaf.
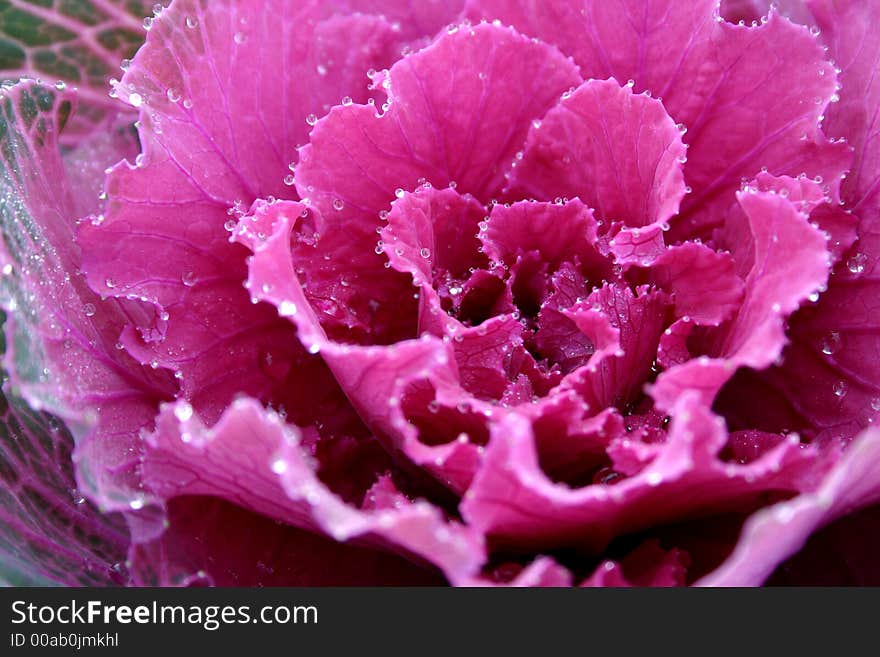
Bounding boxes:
[467,0,852,237]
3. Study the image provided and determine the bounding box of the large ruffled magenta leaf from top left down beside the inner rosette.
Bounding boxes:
[79,2,416,419]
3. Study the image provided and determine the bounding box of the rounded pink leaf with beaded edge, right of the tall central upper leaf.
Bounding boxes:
[507,80,686,233]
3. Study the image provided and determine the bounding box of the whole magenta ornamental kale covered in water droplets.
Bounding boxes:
[0,0,880,586]
